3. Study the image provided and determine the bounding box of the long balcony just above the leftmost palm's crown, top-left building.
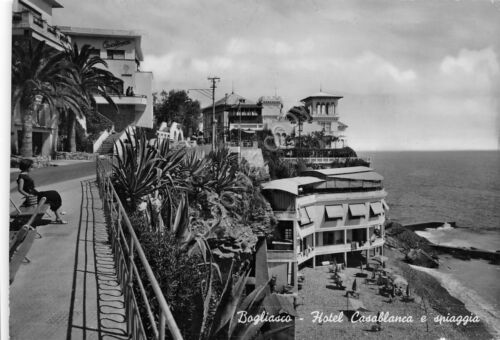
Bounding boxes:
[12,10,71,50]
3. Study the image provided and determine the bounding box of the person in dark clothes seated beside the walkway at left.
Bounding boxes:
[17,159,68,224]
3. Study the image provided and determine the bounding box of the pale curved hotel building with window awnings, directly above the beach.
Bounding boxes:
[263,167,388,291]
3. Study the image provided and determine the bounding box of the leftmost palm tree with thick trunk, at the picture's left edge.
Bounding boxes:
[11,41,81,157]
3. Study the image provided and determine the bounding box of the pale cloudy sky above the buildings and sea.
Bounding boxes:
[50,0,500,150]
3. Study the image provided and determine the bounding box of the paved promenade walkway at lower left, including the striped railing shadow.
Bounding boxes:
[9,179,127,340]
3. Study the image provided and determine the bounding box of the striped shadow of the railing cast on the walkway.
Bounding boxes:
[66,181,128,340]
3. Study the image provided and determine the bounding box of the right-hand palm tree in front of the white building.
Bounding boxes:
[65,44,122,152]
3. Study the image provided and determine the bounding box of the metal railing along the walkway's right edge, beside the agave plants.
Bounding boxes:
[96,159,182,340]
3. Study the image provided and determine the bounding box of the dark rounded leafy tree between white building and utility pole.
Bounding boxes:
[154,90,201,136]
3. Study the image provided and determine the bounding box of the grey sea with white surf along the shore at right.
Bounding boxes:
[358,151,500,339]
